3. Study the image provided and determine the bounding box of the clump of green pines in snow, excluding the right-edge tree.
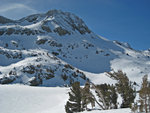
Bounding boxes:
[65,71,136,113]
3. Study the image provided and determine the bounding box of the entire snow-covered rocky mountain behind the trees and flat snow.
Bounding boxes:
[0,10,150,86]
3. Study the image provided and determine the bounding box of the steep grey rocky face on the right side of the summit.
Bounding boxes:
[46,9,91,34]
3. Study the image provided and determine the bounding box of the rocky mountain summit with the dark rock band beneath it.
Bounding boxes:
[0,10,91,36]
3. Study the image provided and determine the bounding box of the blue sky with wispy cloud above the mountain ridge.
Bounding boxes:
[0,0,150,50]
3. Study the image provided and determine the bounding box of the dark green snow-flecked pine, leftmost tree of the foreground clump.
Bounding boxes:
[65,82,83,113]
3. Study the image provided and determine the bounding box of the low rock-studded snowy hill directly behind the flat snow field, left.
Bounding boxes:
[0,49,87,87]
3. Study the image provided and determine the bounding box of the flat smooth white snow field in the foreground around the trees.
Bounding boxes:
[0,85,130,113]
